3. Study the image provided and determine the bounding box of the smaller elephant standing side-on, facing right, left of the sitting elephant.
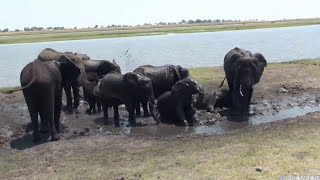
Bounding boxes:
[95,72,157,126]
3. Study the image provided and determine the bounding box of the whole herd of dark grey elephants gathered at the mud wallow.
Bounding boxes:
[12,48,267,141]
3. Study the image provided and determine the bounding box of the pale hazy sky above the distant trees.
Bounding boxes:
[0,0,320,30]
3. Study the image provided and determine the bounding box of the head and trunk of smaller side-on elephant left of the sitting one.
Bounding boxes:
[123,72,159,122]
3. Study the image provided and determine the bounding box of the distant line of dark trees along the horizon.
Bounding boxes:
[0,19,248,32]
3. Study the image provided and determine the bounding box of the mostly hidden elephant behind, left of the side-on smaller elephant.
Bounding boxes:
[83,59,121,114]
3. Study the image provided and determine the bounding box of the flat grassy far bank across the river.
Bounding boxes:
[0,19,320,45]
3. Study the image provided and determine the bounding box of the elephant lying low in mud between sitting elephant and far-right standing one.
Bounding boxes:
[193,89,231,113]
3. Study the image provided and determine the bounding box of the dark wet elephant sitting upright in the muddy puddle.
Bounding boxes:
[157,77,203,126]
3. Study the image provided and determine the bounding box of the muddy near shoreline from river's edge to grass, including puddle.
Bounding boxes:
[0,63,320,150]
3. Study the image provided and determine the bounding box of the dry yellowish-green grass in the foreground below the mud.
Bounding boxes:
[0,117,320,179]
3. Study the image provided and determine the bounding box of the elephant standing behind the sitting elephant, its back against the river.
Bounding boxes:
[133,65,189,116]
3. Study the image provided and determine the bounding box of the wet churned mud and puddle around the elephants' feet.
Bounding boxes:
[0,87,320,149]
